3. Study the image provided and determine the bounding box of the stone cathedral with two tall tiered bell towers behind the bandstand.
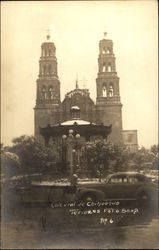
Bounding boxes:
[34,32,137,149]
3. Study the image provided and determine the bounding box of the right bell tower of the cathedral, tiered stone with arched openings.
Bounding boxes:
[96,32,122,143]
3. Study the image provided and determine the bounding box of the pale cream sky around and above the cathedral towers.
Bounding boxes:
[1,0,158,148]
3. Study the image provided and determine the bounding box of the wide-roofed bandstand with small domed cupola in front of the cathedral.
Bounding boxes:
[40,106,112,174]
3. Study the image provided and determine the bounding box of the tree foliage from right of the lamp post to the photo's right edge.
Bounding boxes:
[82,140,158,174]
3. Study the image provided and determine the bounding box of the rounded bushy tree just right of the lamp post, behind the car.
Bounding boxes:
[82,140,131,177]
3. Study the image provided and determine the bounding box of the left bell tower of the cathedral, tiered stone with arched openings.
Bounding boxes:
[34,34,61,136]
